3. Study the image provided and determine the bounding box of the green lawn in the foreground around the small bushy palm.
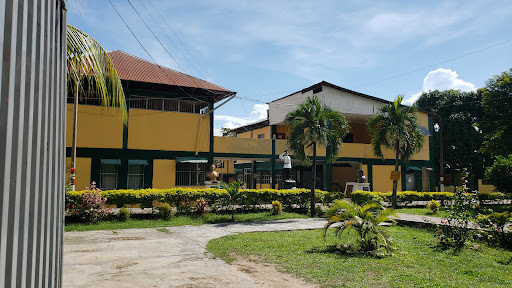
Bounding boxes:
[207,226,512,287]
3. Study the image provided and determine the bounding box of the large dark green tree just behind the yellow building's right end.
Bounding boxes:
[414,90,486,178]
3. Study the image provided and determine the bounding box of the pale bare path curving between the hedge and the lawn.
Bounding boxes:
[63,219,325,287]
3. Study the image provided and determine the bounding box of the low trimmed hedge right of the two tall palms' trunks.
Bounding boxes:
[350,191,506,203]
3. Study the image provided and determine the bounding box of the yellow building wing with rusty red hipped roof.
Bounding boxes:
[66,51,236,190]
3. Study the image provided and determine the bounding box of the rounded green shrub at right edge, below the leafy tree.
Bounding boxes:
[485,154,512,194]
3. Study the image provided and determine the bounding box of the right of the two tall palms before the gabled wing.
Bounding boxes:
[367,95,423,209]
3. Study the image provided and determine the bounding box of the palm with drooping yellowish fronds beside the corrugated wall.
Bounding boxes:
[66,25,128,190]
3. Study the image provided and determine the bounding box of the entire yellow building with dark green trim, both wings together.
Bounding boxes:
[66,51,434,191]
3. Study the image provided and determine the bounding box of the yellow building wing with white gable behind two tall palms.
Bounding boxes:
[232,81,435,192]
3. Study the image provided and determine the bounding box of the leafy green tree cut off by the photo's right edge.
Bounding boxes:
[479,68,512,157]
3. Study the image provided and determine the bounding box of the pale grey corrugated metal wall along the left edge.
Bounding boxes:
[0,0,66,287]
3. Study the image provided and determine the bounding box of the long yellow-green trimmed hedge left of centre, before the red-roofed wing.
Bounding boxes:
[66,188,328,209]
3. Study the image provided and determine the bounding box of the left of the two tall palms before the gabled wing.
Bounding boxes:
[284,95,349,217]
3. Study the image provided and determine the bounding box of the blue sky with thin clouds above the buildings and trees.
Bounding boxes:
[68,0,512,135]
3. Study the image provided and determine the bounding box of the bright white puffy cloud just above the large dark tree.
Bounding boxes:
[402,68,476,105]
